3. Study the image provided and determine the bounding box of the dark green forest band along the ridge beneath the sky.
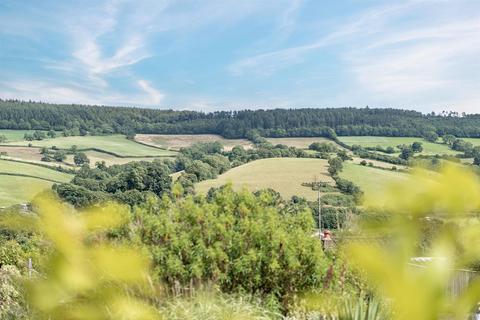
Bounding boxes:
[0,100,480,138]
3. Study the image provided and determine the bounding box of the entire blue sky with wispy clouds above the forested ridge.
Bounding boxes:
[0,0,480,113]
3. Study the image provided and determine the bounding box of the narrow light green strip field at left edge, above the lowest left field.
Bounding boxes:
[0,160,72,182]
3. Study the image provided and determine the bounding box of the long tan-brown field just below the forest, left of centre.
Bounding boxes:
[135,134,253,151]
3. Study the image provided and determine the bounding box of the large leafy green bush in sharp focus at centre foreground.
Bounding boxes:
[135,186,324,308]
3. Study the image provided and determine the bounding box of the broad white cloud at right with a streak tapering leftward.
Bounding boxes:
[228,0,480,112]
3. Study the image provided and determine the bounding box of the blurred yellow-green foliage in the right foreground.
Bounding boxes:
[345,165,480,320]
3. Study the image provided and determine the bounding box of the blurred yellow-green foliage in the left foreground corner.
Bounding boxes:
[1,195,159,320]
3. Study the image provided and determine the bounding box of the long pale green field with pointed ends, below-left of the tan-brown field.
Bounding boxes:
[5,135,175,157]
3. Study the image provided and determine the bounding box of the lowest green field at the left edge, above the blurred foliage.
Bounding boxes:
[0,175,53,207]
